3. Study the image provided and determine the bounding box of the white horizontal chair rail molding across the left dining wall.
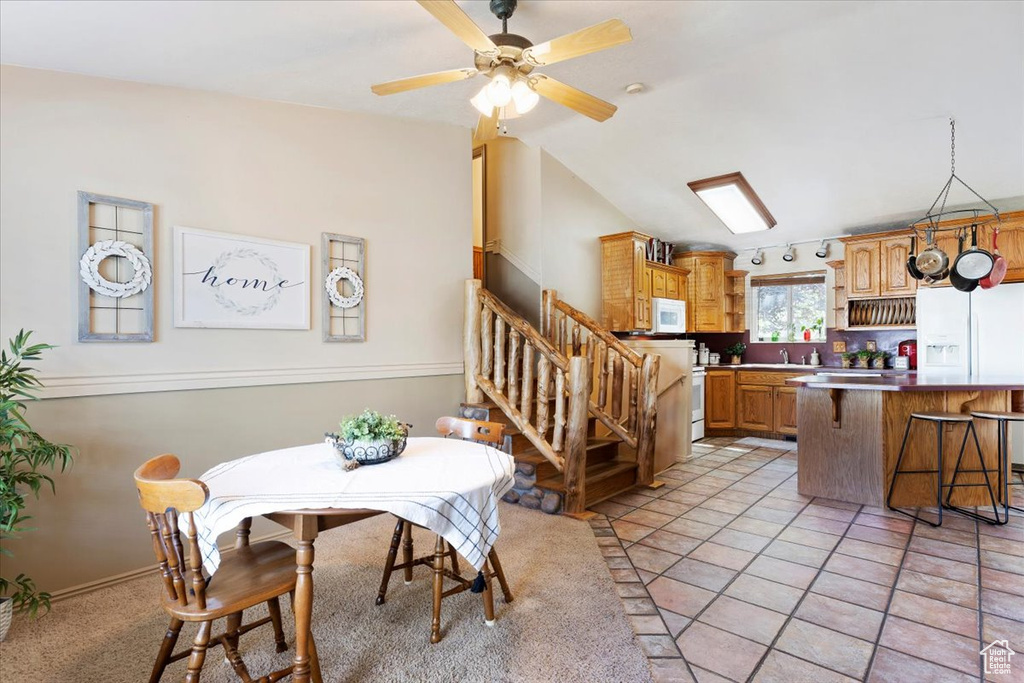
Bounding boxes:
[38,360,463,399]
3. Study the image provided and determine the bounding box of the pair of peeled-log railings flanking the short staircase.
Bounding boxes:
[463,280,658,514]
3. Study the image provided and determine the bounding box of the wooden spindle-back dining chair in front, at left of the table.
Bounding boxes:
[135,455,319,683]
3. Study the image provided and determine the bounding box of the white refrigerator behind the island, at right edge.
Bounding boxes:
[918,283,1024,463]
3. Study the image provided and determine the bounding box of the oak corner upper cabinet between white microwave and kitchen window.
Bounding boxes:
[673,252,742,332]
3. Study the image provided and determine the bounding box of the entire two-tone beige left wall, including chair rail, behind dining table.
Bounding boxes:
[0,67,472,591]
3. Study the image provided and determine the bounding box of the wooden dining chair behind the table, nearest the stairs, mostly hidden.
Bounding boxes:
[377,417,512,643]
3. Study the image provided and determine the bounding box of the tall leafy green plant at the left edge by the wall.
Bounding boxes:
[0,330,72,616]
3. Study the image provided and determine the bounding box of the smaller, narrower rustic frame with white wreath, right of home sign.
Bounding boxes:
[321,232,367,342]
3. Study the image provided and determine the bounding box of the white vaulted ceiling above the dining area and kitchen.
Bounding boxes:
[0,0,1024,249]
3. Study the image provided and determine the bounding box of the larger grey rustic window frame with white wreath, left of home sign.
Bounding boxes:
[76,190,156,342]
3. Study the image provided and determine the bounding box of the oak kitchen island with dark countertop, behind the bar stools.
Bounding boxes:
[786,374,1024,507]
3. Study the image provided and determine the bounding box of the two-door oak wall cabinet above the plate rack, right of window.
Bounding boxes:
[843,231,918,299]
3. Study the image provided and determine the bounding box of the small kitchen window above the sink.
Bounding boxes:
[751,270,826,342]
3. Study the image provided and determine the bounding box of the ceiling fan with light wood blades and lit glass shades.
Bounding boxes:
[371,0,633,141]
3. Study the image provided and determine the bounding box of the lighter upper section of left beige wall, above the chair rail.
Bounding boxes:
[0,67,472,383]
